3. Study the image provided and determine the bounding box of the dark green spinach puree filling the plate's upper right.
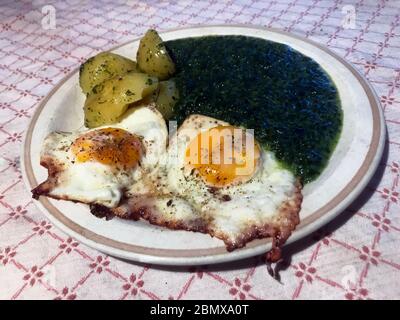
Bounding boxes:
[165,36,342,183]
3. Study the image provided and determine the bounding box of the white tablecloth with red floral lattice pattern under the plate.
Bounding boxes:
[0,0,400,299]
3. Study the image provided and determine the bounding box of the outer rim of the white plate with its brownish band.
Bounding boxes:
[21,24,386,265]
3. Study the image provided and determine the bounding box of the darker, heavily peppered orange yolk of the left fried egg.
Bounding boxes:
[71,128,143,170]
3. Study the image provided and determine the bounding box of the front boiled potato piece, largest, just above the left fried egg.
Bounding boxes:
[83,72,158,128]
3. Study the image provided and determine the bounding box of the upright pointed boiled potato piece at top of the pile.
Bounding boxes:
[136,29,175,80]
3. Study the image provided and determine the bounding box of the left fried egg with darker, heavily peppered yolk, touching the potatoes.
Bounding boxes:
[32,106,168,207]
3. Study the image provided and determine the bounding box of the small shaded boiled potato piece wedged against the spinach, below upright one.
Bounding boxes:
[156,79,179,120]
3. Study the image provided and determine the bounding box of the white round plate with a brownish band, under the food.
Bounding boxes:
[21,25,385,265]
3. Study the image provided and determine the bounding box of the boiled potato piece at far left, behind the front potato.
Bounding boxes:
[79,52,137,94]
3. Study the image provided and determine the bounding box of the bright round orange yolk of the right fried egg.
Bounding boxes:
[185,126,260,188]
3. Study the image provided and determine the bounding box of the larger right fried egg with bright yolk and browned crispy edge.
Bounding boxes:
[94,115,302,251]
